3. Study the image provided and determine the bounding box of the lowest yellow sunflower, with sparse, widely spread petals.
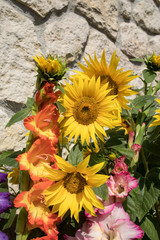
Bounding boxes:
[43,156,108,222]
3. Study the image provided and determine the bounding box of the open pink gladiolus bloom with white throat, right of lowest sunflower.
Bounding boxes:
[106,172,138,198]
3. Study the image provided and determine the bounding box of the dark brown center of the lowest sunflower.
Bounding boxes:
[63,172,87,193]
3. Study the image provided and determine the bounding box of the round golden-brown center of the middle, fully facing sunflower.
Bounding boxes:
[73,97,98,125]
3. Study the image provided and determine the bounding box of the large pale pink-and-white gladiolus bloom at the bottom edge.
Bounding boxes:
[65,202,143,240]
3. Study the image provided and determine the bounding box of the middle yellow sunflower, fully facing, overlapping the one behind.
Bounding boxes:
[60,76,121,146]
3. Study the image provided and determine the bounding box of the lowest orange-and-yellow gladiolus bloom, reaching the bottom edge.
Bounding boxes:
[14,181,60,240]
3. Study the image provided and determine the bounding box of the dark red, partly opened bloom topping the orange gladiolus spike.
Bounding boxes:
[35,82,61,110]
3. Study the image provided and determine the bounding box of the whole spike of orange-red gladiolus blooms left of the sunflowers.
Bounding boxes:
[14,80,60,239]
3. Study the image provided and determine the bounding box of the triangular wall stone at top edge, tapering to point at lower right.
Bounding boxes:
[75,0,118,39]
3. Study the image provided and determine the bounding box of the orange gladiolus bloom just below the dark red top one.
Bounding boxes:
[24,105,59,145]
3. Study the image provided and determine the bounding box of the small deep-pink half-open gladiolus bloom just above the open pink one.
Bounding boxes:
[111,156,128,174]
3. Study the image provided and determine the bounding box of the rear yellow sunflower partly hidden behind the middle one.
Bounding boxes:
[70,49,137,109]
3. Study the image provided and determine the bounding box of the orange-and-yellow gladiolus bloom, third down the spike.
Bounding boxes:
[16,138,58,181]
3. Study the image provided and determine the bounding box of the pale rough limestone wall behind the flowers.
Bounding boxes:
[0,0,160,151]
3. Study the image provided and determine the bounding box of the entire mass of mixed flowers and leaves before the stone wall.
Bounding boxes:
[0,50,160,240]
